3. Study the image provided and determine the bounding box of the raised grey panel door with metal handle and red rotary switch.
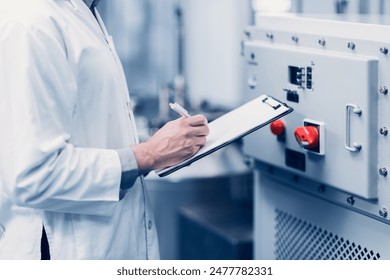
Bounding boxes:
[244,41,378,199]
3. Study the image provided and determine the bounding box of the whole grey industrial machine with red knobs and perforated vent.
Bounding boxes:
[242,14,390,260]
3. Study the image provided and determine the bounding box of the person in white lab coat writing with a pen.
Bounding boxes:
[0,0,208,259]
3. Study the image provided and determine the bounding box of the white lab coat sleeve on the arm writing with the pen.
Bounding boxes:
[0,23,121,216]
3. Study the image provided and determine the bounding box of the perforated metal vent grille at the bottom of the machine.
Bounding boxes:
[275,209,381,260]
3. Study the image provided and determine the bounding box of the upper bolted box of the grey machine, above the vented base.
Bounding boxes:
[242,15,390,221]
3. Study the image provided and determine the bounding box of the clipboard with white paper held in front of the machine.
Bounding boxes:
[155,95,293,177]
